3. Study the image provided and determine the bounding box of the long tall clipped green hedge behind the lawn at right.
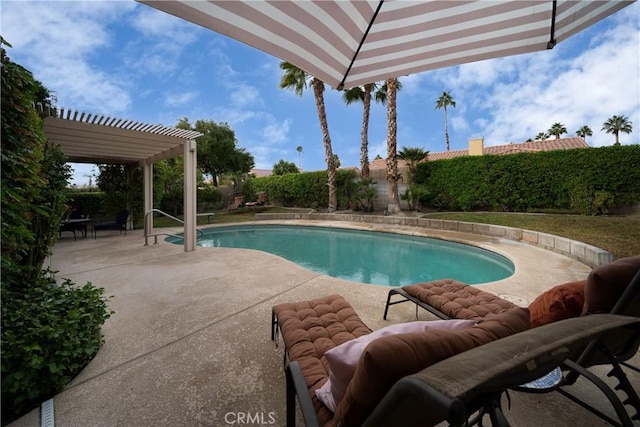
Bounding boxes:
[416,145,640,215]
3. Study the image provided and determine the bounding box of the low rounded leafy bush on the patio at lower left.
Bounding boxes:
[2,279,111,424]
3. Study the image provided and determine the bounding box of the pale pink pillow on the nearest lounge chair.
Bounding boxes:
[315,319,476,412]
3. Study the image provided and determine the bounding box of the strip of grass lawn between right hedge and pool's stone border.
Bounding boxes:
[425,212,640,258]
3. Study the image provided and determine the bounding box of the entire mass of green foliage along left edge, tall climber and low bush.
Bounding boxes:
[0,41,110,423]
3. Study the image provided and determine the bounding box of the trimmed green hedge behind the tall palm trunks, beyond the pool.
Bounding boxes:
[242,170,356,209]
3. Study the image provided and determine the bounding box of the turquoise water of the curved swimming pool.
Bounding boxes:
[166,225,514,286]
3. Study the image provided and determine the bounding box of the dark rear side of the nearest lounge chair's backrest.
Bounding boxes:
[362,314,640,427]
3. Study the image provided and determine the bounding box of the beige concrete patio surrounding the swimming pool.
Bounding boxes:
[7,221,640,427]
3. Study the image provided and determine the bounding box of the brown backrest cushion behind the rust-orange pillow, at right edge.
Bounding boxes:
[582,255,640,314]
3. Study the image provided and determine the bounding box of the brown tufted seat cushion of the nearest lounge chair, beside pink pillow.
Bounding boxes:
[273,295,371,426]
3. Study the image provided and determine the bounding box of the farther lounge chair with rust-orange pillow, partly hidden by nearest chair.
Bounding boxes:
[384,256,640,426]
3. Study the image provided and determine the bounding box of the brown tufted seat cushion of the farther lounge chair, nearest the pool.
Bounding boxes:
[402,279,517,320]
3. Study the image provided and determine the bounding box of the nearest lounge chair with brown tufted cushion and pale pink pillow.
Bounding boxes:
[271,295,640,427]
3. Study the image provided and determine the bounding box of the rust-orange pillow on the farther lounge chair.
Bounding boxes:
[529,280,587,328]
